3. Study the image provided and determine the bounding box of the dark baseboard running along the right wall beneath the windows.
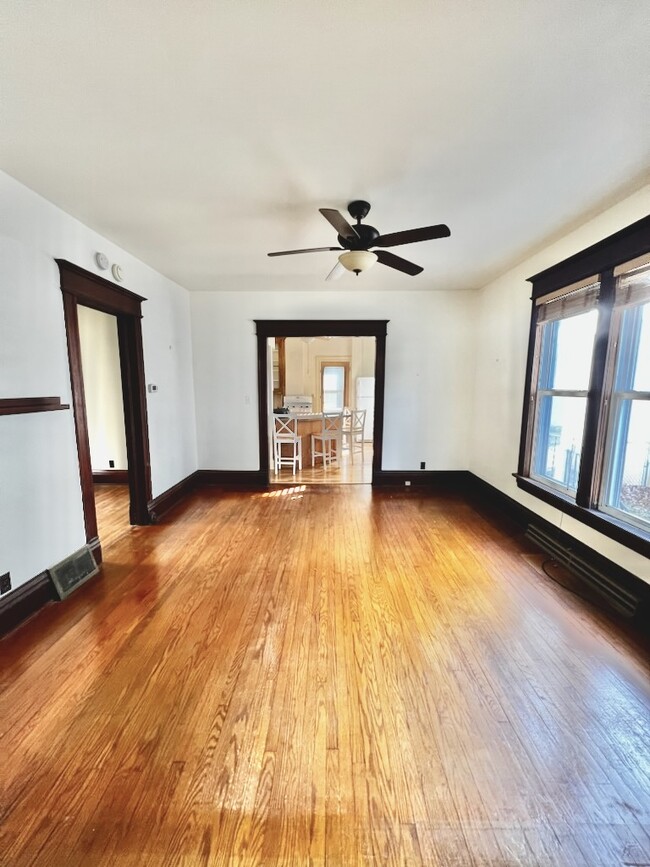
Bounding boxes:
[466,473,650,633]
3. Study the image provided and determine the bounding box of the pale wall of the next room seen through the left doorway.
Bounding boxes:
[77,306,128,471]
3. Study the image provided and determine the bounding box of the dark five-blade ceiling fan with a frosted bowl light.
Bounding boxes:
[268,200,451,280]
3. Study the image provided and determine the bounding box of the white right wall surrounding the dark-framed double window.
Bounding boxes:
[470,186,650,581]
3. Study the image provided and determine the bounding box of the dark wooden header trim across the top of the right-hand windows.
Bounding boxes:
[528,216,650,298]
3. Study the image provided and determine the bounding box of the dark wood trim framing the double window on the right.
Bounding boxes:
[514,216,650,557]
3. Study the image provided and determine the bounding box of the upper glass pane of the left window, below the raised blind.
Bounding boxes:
[540,310,598,391]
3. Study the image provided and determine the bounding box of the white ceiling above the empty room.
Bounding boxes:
[0,0,650,290]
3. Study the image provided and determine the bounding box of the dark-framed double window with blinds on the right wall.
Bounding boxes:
[517,217,650,555]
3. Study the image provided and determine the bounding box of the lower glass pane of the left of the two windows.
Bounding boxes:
[533,395,587,491]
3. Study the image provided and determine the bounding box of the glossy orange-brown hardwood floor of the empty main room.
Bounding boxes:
[0,485,650,867]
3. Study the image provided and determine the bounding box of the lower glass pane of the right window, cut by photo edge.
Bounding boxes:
[605,400,650,526]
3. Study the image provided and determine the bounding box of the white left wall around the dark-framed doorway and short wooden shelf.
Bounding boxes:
[0,173,197,588]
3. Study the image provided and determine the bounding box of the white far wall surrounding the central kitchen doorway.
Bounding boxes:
[191,284,474,470]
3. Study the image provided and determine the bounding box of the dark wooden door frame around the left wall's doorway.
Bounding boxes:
[56,259,152,560]
